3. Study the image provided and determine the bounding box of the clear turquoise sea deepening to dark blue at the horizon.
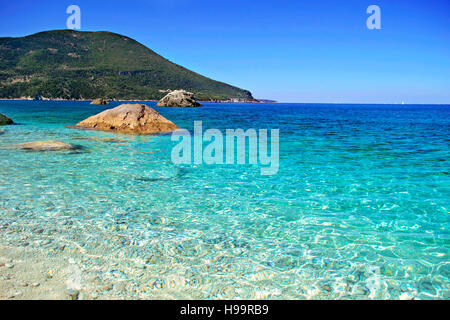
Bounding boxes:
[0,101,450,299]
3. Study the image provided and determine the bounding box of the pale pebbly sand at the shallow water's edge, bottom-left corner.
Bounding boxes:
[0,245,200,300]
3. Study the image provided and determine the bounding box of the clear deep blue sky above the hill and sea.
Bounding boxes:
[0,0,450,103]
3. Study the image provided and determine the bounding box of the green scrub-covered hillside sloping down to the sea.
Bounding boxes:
[0,30,253,100]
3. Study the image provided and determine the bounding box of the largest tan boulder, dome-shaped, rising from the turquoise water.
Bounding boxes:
[74,104,178,134]
